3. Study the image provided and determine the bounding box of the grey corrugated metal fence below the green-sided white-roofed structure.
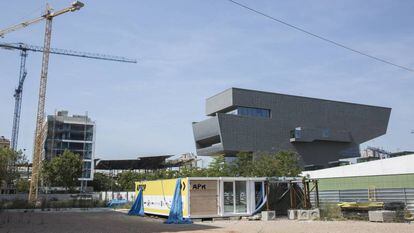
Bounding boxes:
[311,188,414,213]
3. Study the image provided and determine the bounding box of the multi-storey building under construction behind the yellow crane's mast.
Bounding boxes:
[45,111,95,180]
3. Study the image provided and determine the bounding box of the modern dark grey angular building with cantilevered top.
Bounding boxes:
[193,88,391,165]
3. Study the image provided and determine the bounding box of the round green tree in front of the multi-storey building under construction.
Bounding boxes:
[42,150,82,191]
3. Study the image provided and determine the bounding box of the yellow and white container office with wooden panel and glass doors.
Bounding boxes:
[135,177,266,218]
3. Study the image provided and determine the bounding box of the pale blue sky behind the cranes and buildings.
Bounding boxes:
[0,0,414,158]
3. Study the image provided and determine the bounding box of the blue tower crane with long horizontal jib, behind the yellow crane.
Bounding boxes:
[0,43,137,150]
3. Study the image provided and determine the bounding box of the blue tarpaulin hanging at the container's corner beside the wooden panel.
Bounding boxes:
[164,178,192,224]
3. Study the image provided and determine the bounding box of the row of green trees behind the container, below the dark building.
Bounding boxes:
[94,151,301,191]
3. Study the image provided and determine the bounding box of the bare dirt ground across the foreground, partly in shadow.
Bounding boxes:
[0,212,414,233]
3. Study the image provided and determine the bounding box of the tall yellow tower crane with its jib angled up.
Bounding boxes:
[0,1,84,203]
